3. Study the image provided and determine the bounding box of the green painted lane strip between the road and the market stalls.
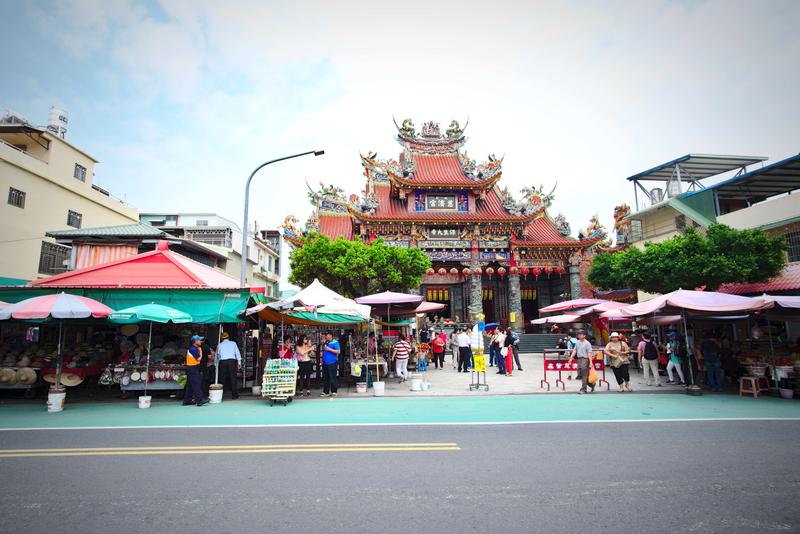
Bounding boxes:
[0,394,800,429]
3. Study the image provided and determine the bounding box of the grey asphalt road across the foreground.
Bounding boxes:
[0,421,800,534]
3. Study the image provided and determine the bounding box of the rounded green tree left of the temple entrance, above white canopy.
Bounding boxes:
[289,233,431,298]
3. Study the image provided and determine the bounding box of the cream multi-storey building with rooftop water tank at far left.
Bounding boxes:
[0,108,139,284]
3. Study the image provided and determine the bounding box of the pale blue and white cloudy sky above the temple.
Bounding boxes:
[0,0,800,254]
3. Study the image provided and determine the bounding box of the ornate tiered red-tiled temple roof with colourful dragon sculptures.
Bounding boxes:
[283,119,598,248]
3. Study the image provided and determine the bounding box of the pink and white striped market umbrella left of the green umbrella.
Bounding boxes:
[0,293,114,320]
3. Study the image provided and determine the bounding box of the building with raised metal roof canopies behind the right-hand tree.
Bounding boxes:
[626,154,800,300]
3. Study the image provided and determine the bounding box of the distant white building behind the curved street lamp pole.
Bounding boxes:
[139,213,281,296]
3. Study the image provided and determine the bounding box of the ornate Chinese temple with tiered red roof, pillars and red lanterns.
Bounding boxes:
[283,119,605,331]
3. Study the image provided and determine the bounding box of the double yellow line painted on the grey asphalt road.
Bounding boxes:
[0,446,461,458]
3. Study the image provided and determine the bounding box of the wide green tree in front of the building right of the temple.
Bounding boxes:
[588,224,786,293]
